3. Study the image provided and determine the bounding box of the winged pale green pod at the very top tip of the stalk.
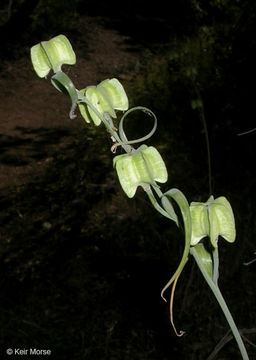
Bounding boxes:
[30,35,76,78]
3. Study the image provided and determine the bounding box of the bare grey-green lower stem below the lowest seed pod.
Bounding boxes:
[190,247,249,360]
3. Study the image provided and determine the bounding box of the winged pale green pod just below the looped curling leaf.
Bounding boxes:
[113,145,168,198]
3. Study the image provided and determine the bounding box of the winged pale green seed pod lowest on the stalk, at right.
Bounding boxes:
[190,196,236,248]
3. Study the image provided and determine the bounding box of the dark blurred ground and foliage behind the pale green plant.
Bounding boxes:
[0,0,256,360]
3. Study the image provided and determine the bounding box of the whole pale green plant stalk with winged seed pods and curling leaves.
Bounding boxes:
[31,35,249,360]
